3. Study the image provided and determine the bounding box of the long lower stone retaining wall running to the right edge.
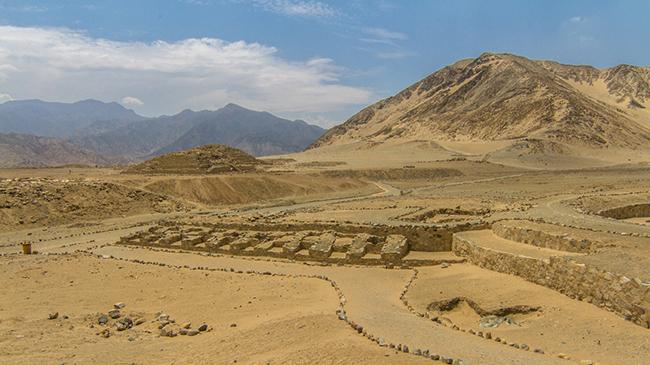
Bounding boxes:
[452,235,650,328]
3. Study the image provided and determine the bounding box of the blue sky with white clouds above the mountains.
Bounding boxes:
[0,0,650,126]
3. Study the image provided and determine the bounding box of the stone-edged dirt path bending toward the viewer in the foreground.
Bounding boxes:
[87,246,566,365]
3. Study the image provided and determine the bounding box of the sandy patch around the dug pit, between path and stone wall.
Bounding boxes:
[407,264,650,365]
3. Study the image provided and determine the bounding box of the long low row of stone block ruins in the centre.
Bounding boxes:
[119,222,424,265]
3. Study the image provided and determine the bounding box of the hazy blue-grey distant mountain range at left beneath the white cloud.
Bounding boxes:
[0,100,324,166]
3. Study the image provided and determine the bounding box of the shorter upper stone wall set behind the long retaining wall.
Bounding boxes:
[492,222,592,253]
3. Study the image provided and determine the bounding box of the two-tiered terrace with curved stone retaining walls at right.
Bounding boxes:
[453,225,650,328]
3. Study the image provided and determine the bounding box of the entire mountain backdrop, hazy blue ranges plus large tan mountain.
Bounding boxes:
[5,53,650,168]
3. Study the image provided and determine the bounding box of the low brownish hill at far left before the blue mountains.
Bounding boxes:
[0,133,108,168]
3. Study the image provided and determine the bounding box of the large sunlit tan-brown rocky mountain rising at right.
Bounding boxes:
[310,53,650,168]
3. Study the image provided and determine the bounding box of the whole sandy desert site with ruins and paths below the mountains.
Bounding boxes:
[0,154,650,365]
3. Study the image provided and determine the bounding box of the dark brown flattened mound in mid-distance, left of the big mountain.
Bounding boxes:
[125,144,263,175]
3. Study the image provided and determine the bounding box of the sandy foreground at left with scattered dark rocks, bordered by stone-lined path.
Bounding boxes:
[0,256,429,364]
